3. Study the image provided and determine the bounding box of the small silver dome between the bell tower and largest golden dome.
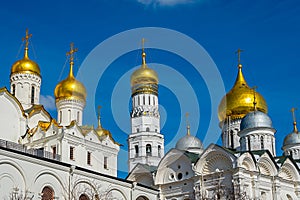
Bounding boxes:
[175,134,203,151]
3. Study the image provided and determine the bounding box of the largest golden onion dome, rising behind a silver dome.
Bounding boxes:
[218,64,268,122]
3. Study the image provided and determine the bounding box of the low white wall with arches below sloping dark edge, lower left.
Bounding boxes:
[0,149,158,200]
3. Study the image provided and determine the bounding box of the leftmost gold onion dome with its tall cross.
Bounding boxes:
[11,29,41,76]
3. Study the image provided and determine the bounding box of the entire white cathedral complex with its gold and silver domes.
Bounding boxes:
[0,31,300,200]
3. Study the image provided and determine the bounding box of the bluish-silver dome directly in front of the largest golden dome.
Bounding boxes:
[240,111,273,131]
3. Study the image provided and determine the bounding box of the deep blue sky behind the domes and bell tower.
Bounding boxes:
[0,0,300,176]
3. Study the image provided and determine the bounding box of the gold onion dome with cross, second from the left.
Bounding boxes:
[54,43,86,102]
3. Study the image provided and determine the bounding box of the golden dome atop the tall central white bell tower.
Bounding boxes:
[130,51,158,87]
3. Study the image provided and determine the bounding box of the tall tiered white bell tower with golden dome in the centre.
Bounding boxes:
[128,40,164,172]
